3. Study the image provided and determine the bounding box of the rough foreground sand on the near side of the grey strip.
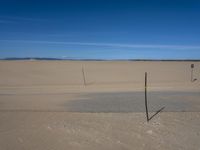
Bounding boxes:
[0,112,200,150]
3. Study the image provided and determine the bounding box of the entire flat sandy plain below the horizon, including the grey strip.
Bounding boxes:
[0,61,200,150]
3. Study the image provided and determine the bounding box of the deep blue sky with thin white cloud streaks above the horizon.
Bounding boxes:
[0,0,200,59]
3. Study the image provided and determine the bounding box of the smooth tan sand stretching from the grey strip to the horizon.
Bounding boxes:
[0,61,200,92]
